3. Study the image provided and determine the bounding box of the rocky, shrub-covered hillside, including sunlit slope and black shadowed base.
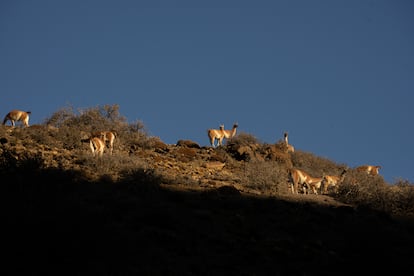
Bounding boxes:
[0,105,414,275]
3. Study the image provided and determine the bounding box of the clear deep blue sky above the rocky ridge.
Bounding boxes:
[0,0,414,183]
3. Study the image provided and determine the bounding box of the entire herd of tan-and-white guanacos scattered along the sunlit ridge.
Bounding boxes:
[3,110,381,194]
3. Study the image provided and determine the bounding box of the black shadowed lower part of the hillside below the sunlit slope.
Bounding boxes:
[1,166,414,275]
